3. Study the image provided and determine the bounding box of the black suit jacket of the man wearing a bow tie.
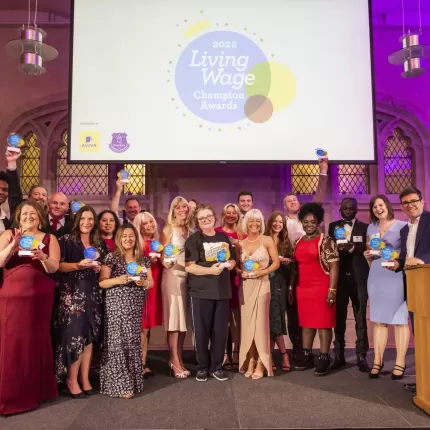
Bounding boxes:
[328,219,369,288]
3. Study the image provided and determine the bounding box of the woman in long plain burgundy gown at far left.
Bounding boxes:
[0,201,60,415]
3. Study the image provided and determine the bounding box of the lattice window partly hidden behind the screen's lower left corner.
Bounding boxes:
[57,130,109,196]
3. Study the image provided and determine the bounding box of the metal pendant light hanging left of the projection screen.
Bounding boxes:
[5,0,58,75]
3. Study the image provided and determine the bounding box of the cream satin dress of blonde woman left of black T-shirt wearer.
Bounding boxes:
[161,227,188,332]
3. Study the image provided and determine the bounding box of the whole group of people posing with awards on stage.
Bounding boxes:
[0,151,430,415]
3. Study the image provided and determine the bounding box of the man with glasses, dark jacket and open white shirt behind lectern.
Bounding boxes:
[392,187,430,393]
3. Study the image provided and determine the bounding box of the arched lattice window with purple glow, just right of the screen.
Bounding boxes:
[384,128,414,194]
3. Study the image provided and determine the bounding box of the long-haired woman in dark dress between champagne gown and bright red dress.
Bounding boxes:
[265,211,292,372]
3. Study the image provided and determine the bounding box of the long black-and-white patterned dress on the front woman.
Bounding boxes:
[100,253,151,397]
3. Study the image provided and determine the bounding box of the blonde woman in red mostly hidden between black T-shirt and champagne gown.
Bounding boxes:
[215,203,247,370]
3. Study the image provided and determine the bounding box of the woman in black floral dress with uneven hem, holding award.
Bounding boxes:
[53,206,106,398]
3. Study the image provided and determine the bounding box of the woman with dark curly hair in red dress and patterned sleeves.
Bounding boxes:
[291,203,339,376]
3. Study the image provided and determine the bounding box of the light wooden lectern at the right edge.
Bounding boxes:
[406,264,430,415]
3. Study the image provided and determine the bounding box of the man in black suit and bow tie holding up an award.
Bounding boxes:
[329,198,369,372]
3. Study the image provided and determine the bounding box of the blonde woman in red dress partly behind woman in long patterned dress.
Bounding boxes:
[133,212,163,378]
